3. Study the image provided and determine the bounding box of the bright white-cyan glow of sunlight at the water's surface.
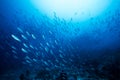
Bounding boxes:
[32,0,112,22]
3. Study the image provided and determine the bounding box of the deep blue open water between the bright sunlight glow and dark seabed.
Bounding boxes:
[0,0,120,79]
